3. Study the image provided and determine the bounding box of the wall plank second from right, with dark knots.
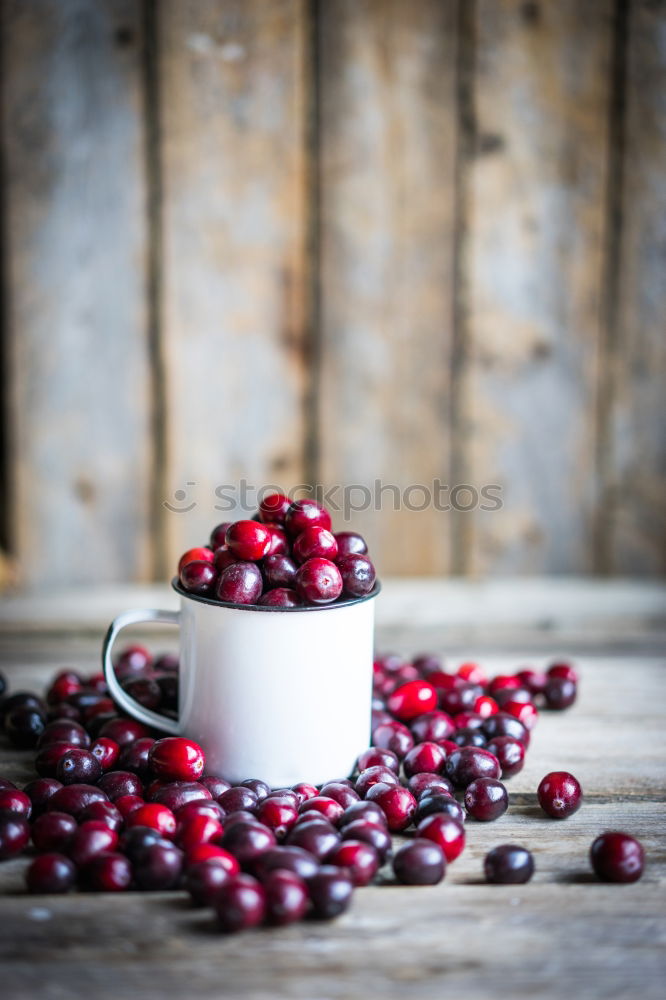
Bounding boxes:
[461,0,612,574]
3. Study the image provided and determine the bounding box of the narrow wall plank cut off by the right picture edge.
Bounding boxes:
[601,0,666,575]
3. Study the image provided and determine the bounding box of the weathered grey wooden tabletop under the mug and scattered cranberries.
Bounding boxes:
[0,580,666,1000]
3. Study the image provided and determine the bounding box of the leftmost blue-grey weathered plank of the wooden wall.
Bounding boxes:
[1,0,151,586]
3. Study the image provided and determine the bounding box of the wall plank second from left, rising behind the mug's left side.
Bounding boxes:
[157,0,307,565]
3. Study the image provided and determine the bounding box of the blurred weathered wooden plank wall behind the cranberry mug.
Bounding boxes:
[0,0,666,586]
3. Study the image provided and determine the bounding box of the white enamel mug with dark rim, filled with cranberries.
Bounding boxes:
[102,580,380,788]
